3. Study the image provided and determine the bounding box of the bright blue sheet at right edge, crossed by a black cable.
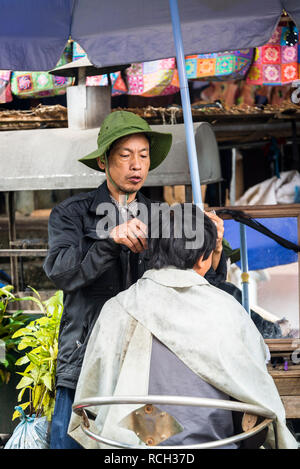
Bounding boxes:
[224,217,298,270]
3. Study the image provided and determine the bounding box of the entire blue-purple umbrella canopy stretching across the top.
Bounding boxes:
[0,0,300,71]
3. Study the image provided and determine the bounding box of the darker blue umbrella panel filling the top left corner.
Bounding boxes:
[0,0,73,71]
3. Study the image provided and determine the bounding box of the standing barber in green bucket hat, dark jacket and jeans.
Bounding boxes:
[44,111,172,449]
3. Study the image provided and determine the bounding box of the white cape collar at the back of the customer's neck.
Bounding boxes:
[142,266,209,288]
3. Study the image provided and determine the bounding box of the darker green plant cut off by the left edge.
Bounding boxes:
[0,285,31,385]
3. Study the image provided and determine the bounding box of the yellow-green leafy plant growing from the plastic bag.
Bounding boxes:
[13,290,63,420]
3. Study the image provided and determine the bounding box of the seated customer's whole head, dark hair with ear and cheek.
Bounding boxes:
[148,204,217,276]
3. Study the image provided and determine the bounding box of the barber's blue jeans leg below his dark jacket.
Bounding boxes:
[50,386,82,449]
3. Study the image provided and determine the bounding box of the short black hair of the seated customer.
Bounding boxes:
[147,204,217,269]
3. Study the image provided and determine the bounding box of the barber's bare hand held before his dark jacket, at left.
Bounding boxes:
[109,218,147,253]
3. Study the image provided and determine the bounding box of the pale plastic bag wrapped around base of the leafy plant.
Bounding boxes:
[4,406,49,449]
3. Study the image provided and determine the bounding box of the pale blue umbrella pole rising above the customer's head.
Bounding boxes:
[169,0,203,208]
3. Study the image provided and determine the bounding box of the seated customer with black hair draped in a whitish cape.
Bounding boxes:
[69,205,297,449]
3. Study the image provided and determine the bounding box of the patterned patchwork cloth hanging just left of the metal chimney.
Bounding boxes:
[11,44,73,98]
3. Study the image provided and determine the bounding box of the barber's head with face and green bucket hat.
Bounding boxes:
[79,111,172,202]
